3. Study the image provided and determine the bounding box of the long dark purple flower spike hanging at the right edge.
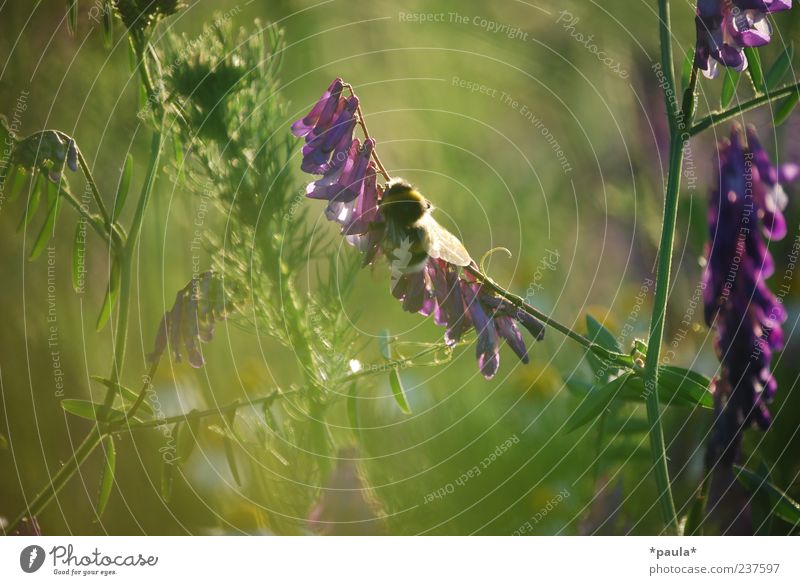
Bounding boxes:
[703,126,800,464]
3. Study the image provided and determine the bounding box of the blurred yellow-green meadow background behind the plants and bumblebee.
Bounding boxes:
[0,0,800,534]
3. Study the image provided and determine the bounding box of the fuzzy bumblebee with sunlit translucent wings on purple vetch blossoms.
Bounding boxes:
[380,179,472,273]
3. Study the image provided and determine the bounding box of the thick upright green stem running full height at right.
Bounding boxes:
[644,0,683,534]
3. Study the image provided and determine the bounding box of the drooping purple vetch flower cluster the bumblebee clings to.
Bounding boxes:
[292,78,544,379]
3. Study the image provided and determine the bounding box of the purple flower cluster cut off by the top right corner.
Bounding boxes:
[695,0,792,79]
